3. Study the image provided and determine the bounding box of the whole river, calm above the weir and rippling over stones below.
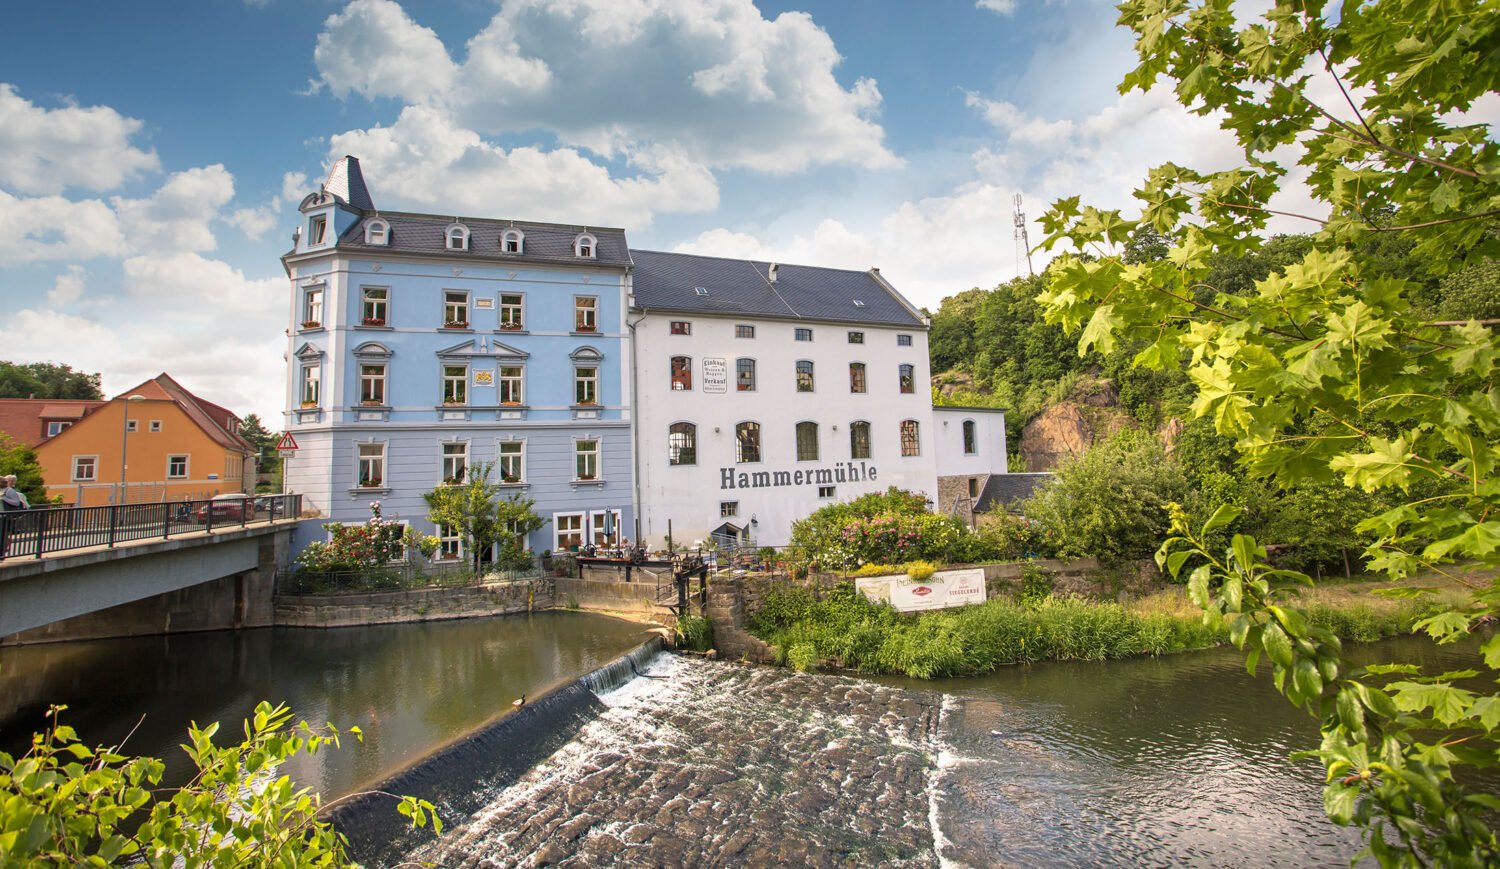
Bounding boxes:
[0,612,1476,866]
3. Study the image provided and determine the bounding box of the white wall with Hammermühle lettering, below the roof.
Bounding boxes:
[635,311,936,546]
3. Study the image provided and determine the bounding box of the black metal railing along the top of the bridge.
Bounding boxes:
[0,495,302,558]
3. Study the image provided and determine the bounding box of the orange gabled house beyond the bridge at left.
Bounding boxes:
[36,374,255,507]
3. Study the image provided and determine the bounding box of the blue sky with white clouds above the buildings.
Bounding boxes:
[0,0,1314,429]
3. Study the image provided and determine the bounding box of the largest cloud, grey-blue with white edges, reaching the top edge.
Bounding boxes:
[314,0,902,173]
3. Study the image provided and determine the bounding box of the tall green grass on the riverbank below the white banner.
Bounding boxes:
[749,582,1452,678]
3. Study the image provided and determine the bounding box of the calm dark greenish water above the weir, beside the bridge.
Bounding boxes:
[0,612,647,798]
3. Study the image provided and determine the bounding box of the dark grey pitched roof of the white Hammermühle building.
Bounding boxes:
[624,250,926,329]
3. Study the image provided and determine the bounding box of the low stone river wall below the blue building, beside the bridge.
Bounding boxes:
[276,576,554,627]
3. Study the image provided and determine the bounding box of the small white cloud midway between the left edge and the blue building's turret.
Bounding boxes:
[113,164,234,252]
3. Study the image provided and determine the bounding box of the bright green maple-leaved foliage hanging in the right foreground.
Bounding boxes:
[1041,0,1500,866]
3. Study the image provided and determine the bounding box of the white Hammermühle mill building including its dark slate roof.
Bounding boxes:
[630,251,936,545]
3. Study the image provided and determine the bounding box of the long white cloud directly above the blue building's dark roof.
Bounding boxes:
[330,107,719,228]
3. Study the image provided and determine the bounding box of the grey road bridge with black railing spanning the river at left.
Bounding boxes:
[0,495,302,639]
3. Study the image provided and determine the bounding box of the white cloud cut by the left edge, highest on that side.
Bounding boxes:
[0,84,159,194]
